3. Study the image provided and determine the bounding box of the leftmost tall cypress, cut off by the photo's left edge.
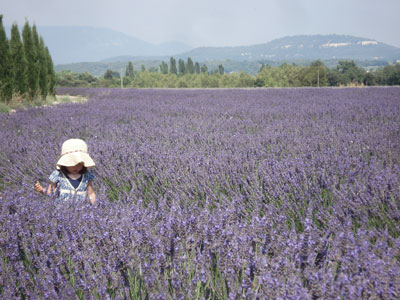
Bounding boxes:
[0,15,13,103]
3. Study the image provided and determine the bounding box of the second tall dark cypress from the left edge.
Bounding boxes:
[10,24,27,95]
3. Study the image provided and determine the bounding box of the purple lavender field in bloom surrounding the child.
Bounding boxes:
[0,88,400,299]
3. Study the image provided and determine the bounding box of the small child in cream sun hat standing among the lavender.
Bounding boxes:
[34,139,96,204]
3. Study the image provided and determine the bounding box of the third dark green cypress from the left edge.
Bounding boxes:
[22,21,39,102]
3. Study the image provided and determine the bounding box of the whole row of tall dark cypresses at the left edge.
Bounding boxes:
[0,15,56,104]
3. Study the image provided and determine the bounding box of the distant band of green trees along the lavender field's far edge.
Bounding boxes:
[57,57,400,88]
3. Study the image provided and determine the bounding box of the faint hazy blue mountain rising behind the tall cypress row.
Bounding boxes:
[6,26,192,64]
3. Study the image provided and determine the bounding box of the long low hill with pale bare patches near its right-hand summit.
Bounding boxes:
[173,35,400,61]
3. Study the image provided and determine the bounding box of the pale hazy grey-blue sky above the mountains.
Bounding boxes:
[0,0,400,47]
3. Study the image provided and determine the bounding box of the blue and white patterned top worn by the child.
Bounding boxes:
[49,170,95,201]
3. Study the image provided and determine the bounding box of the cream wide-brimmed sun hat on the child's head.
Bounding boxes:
[57,139,95,169]
